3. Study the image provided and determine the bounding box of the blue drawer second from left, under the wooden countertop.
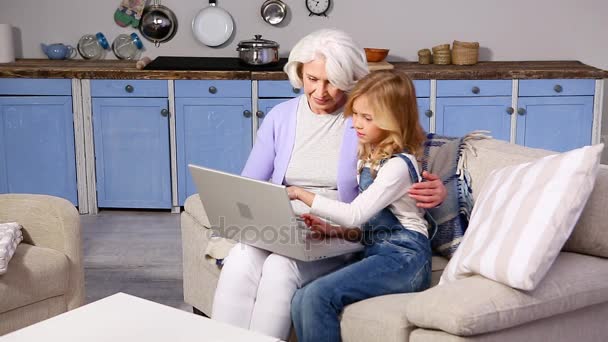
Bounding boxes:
[91,80,168,97]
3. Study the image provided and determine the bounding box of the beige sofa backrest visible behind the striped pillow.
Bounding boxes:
[464,139,608,258]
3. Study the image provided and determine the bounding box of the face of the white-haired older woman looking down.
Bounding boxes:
[302,58,346,114]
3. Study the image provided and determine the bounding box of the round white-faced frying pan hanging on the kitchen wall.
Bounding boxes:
[192,0,234,46]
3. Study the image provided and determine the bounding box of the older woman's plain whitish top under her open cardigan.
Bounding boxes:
[285,96,346,214]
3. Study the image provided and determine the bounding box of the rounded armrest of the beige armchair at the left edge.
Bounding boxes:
[0,194,84,309]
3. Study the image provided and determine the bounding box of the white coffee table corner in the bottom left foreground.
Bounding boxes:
[0,293,279,342]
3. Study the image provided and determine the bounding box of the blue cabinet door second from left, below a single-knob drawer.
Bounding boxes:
[93,98,171,208]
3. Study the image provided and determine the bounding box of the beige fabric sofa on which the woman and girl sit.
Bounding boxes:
[181,139,608,342]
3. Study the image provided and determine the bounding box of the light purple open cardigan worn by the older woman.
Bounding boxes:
[241,95,359,203]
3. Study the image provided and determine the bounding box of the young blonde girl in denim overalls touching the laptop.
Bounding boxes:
[288,71,431,342]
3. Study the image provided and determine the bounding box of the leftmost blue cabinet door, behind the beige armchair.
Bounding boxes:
[0,96,77,205]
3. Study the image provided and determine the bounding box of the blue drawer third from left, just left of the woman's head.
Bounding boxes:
[175,80,251,97]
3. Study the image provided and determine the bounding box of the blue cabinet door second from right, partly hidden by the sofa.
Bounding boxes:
[435,96,511,141]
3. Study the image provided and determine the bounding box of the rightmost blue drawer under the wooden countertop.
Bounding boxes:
[519,79,595,96]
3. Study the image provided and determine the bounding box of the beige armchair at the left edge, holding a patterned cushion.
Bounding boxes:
[0,194,84,335]
